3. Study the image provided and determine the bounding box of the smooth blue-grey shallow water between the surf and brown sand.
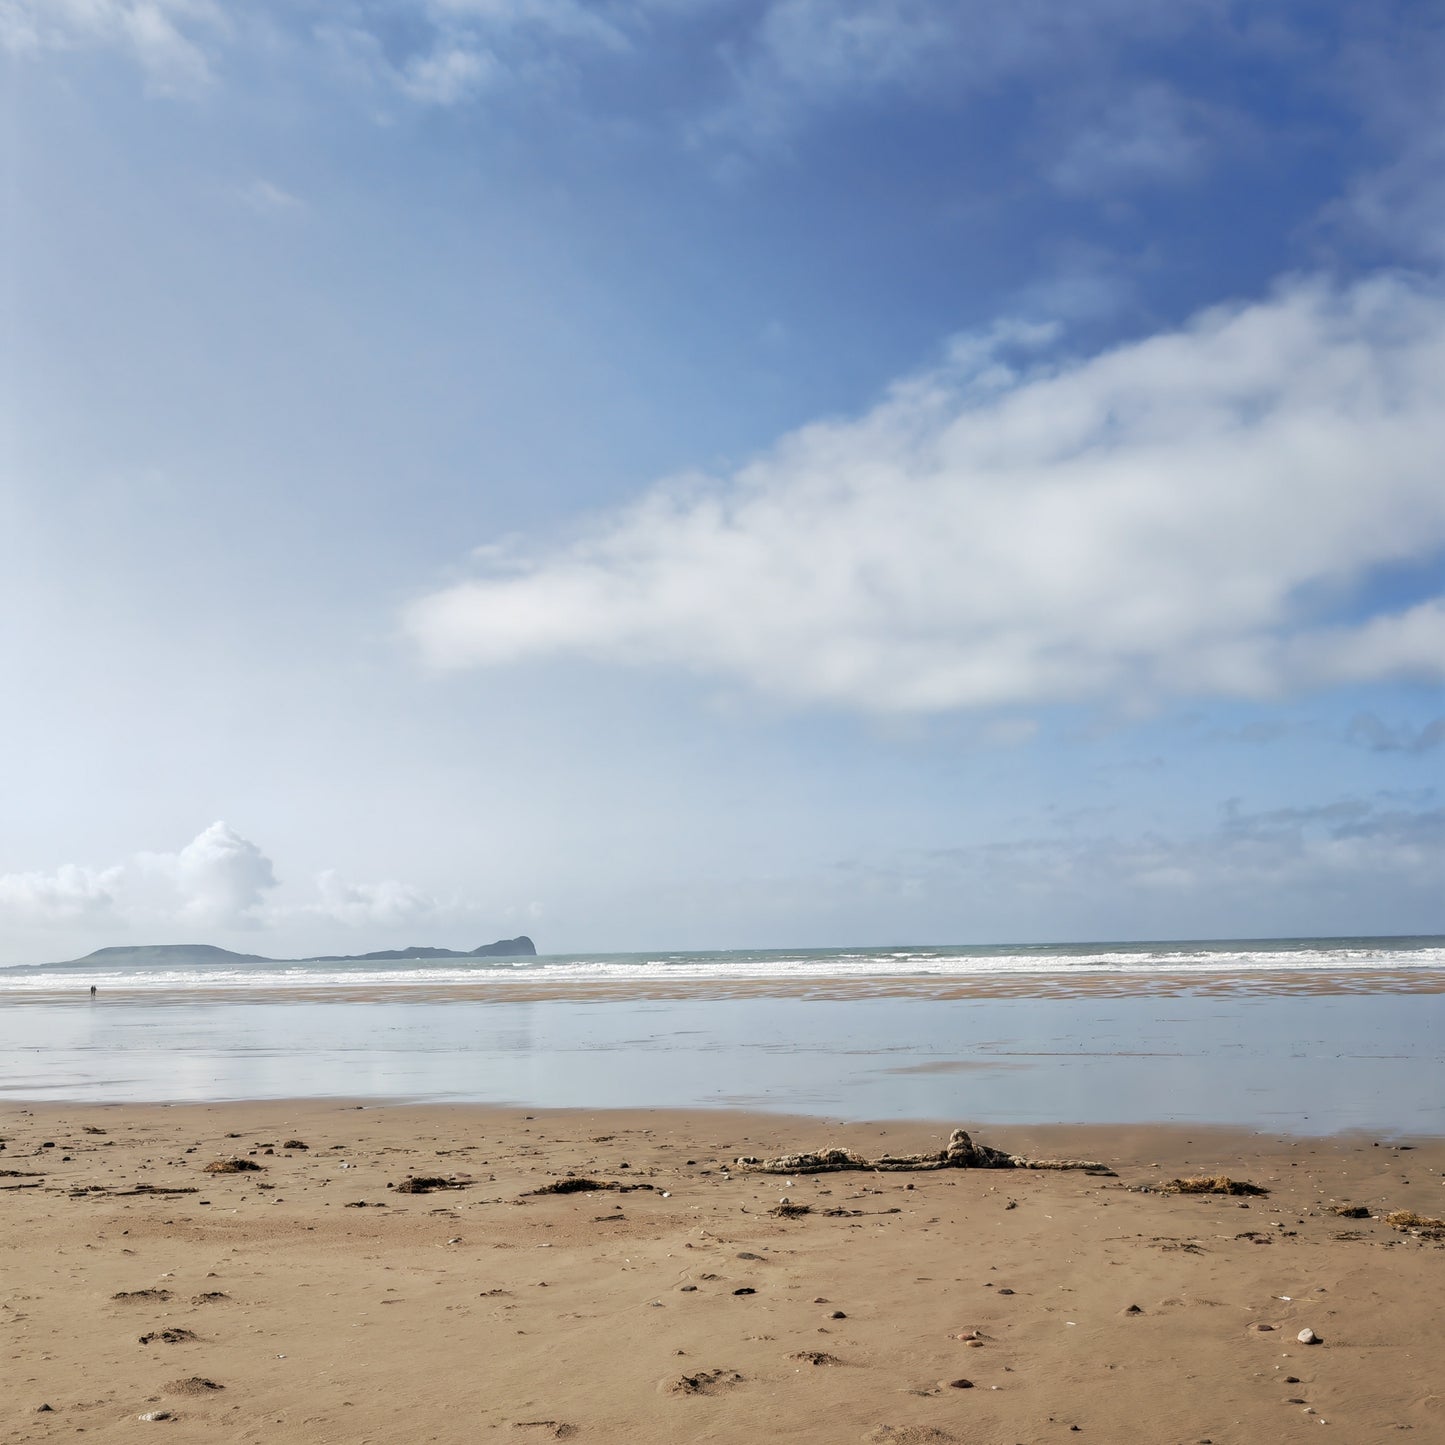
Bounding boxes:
[0,993,1445,1134]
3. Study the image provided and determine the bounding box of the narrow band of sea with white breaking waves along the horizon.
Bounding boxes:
[0,935,1445,1001]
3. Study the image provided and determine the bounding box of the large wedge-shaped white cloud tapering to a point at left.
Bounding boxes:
[405,276,1445,712]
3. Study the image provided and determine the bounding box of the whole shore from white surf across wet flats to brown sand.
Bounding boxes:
[0,945,1445,1445]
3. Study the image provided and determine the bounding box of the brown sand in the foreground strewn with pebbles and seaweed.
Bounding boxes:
[0,1101,1445,1445]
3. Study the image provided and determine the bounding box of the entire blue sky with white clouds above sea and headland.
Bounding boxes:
[0,0,1445,962]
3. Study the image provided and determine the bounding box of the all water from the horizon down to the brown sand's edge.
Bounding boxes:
[0,936,1445,1139]
